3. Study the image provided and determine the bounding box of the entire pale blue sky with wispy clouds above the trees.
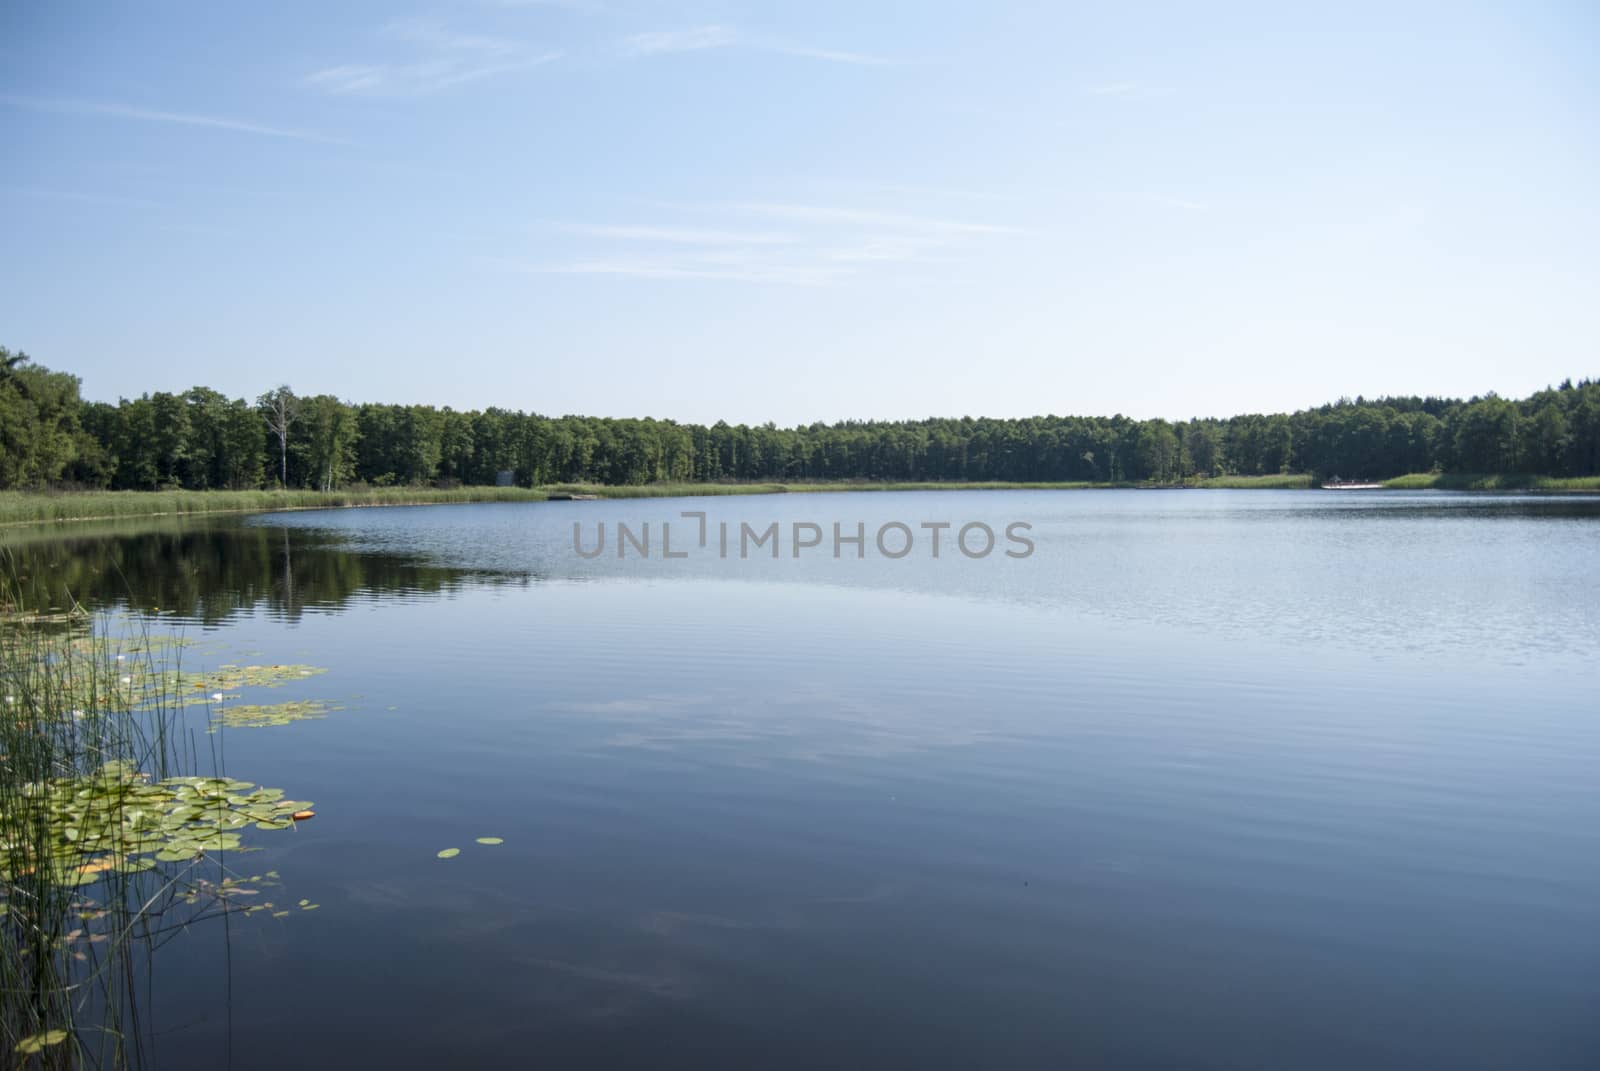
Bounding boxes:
[0,0,1600,424]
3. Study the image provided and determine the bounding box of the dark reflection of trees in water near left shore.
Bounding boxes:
[5,520,533,624]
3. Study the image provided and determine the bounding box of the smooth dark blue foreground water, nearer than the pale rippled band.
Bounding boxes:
[156,581,1600,1068]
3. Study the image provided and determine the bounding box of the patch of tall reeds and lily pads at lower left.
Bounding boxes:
[0,583,310,1068]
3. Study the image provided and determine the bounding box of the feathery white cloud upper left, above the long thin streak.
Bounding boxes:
[304,19,562,96]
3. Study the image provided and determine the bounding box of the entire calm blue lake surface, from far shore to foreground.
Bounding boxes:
[0,491,1600,1071]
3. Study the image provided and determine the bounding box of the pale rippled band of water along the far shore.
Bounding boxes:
[254,491,1600,660]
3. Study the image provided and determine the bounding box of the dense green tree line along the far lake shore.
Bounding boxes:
[0,347,1600,490]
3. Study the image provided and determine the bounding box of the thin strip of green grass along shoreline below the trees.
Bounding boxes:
[12,472,1600,527]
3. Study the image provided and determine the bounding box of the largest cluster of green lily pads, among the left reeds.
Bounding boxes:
[0,762,314,885]
